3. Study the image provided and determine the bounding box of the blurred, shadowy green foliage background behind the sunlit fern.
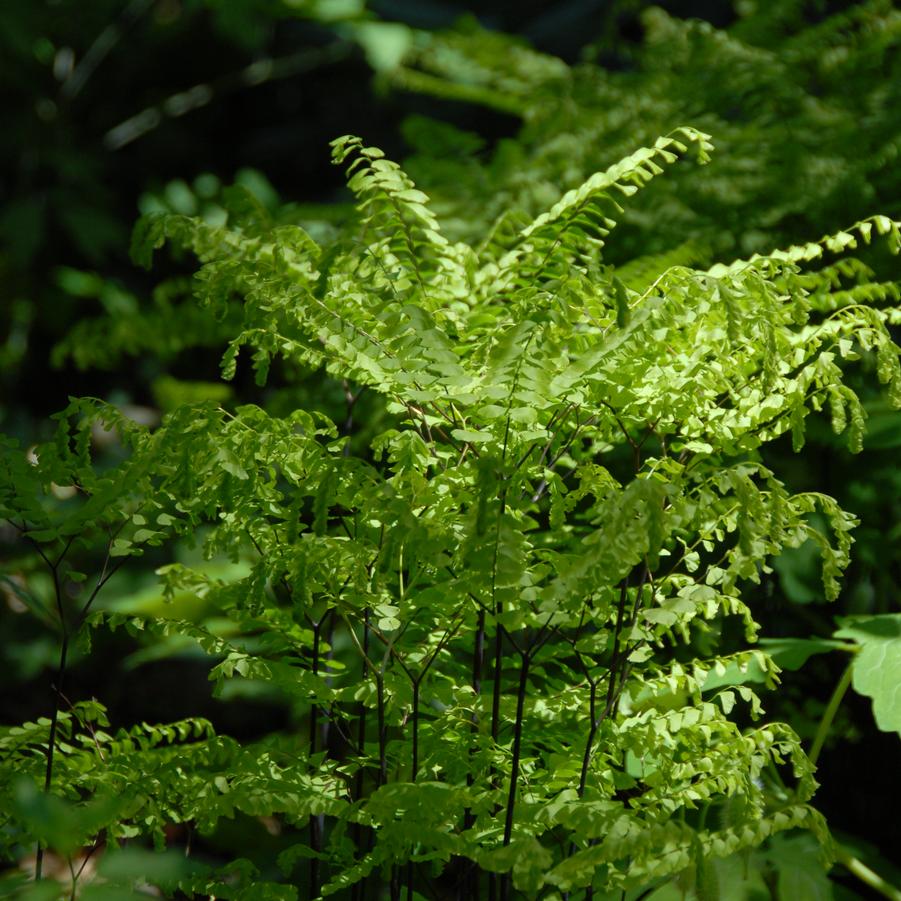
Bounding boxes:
[0,0,901,897]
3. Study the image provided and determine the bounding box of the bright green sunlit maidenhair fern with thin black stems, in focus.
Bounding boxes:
[0,125,901,899]
